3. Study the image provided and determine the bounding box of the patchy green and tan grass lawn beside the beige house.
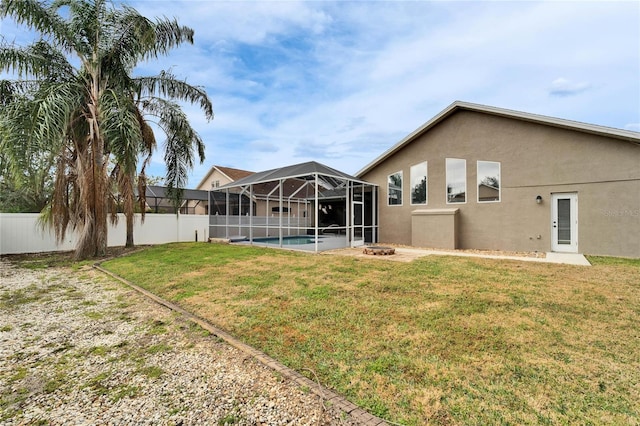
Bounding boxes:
[103,243,640,425]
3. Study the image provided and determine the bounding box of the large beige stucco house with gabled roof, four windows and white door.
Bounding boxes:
[356,102,640,258]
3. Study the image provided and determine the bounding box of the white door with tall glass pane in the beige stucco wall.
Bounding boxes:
[551,193,578,253]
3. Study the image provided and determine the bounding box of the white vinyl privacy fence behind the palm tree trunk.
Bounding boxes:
[0,213,209,254]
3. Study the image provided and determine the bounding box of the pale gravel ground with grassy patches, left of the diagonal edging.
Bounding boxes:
[0,259,356,425]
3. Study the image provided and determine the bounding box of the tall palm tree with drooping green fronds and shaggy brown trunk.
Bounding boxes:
[0,0,213,259]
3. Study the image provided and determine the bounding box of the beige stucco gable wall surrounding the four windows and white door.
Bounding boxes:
[361,111,640,257]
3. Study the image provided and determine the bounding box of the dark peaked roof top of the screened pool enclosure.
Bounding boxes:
[217,161,368,189]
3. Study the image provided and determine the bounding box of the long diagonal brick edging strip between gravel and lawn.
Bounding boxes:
[93,263,388,426]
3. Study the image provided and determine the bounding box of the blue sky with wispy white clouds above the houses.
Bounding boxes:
[0,0,640,187]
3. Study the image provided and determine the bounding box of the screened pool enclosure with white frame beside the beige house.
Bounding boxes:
[209,161,378,252]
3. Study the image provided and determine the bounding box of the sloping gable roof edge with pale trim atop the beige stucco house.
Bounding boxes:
[356,101,640,177]
